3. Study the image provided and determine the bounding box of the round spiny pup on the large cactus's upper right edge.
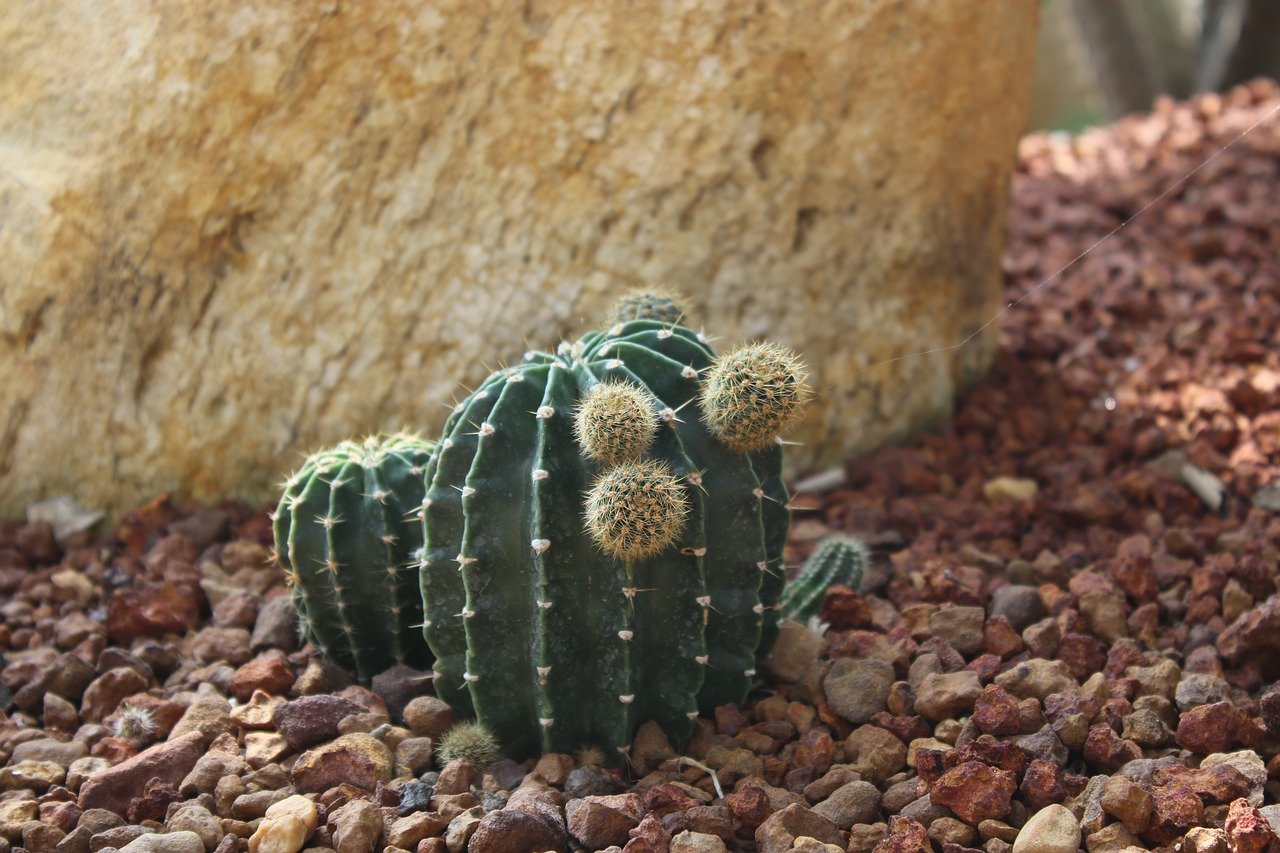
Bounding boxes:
[701,342,809,453]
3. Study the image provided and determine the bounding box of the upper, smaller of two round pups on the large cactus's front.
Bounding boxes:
[573,382,658,465]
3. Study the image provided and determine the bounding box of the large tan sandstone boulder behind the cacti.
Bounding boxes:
[0,0,1036,515]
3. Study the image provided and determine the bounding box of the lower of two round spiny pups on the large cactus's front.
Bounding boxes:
[586,461,689,561]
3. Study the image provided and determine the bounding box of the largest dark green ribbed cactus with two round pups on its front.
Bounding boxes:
[420,318,790,760]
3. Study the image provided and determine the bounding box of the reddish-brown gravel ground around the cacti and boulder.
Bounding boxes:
[0,82,1280,853]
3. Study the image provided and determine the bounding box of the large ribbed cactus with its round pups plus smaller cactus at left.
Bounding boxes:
[276,293,806,757]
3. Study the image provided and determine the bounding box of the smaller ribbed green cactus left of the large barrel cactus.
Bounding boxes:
[273,434,434,681]
